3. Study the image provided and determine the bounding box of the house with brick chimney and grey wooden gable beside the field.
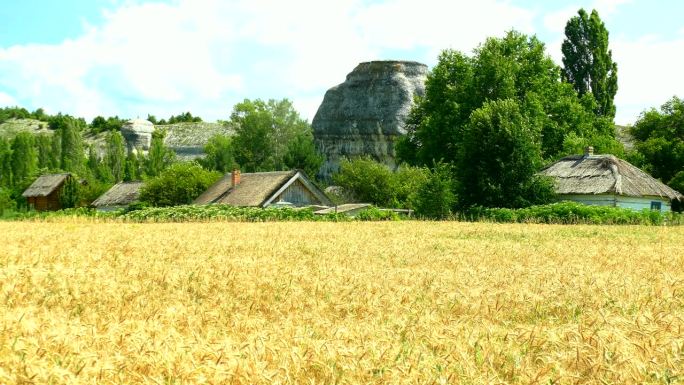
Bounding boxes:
[194,170,332,207]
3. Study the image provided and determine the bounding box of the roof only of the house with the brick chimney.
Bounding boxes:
[194,170,329,207]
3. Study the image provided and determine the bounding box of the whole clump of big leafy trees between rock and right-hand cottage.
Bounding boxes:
[397,31,620,206]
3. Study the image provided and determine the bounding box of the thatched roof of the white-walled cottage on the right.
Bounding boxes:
[539,155,684,200]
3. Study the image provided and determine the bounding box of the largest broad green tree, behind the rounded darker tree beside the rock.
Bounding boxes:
[397,31,621,205]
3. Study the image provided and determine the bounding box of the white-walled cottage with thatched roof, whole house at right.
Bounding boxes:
[539,148,684,211]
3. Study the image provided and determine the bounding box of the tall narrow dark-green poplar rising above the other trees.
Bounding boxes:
[561,9,617,120]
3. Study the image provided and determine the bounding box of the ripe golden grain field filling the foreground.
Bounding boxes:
[0,220,684,384]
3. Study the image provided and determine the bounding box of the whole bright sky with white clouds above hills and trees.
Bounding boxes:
[0,0,684,124]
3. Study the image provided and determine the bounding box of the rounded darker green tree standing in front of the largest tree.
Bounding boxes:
[457,99,553,207]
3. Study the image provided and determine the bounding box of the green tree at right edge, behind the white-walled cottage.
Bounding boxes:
[630,97,684,186]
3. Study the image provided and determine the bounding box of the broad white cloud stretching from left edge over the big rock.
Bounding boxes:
[0,0,533,119]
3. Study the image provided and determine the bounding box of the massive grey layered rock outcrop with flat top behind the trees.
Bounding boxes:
[312,61,428,180]
